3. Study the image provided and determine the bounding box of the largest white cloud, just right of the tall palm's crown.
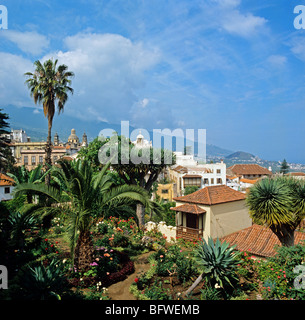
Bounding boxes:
[42,33,160,122]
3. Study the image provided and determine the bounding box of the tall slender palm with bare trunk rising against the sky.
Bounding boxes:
[25,59,74,184]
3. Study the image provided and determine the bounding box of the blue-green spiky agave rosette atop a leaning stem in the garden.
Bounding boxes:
[194,237,239,289]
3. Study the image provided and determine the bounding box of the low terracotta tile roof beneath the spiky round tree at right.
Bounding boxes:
[220,224,305,257]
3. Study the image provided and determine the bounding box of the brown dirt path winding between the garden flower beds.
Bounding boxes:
[108,252,151,300]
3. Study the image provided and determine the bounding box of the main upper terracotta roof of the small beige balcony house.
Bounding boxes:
[173,185,246,206]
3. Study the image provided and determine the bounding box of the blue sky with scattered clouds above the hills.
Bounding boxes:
[0,0,305,163]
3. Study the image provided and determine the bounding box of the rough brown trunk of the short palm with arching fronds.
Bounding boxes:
[74,230,94,271]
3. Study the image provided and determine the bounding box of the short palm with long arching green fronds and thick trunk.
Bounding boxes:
[15,160,150,270]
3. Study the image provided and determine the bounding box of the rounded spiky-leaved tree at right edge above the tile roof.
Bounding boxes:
[246,176,305,246]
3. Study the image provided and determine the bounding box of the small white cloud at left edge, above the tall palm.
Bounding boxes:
[1,30,50,55]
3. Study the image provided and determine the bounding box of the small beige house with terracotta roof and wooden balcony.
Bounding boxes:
[171,185,252,240]
